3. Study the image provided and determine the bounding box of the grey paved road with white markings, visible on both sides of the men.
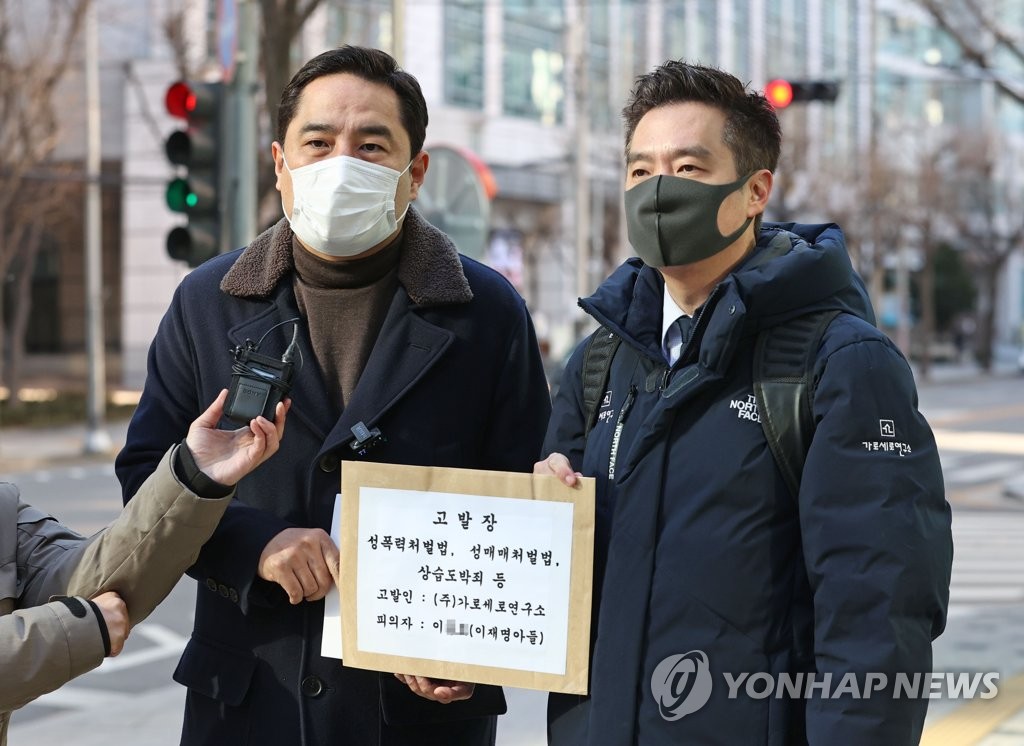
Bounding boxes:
[6,364,1024,746]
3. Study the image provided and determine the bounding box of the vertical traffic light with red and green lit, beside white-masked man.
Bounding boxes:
[164,81,223,267]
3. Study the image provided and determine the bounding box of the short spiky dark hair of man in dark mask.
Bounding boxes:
[623,59,782,177]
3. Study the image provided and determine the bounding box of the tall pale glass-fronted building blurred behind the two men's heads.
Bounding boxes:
[129,0,870,372]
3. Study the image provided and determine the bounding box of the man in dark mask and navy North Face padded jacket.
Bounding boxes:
[535,61,952,746]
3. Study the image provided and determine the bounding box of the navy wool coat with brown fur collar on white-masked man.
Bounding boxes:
[116,209,550,746]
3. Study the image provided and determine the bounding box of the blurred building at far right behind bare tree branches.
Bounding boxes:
[871,0,1024,361]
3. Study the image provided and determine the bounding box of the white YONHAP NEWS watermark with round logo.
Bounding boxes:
[650,650,999,720]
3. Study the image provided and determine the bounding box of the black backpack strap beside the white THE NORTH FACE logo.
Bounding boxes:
[754,310,840,498]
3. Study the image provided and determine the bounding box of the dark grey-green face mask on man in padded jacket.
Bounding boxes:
[626,175,754,267]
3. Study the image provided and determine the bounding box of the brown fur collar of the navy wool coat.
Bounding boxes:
[220,206,473,306]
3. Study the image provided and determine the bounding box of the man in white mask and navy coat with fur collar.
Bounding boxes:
[117,47,550,746]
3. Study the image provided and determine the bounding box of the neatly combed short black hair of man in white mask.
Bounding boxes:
[278,44,427,156]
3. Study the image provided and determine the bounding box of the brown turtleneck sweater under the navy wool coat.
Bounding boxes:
[292,234,404,414]
